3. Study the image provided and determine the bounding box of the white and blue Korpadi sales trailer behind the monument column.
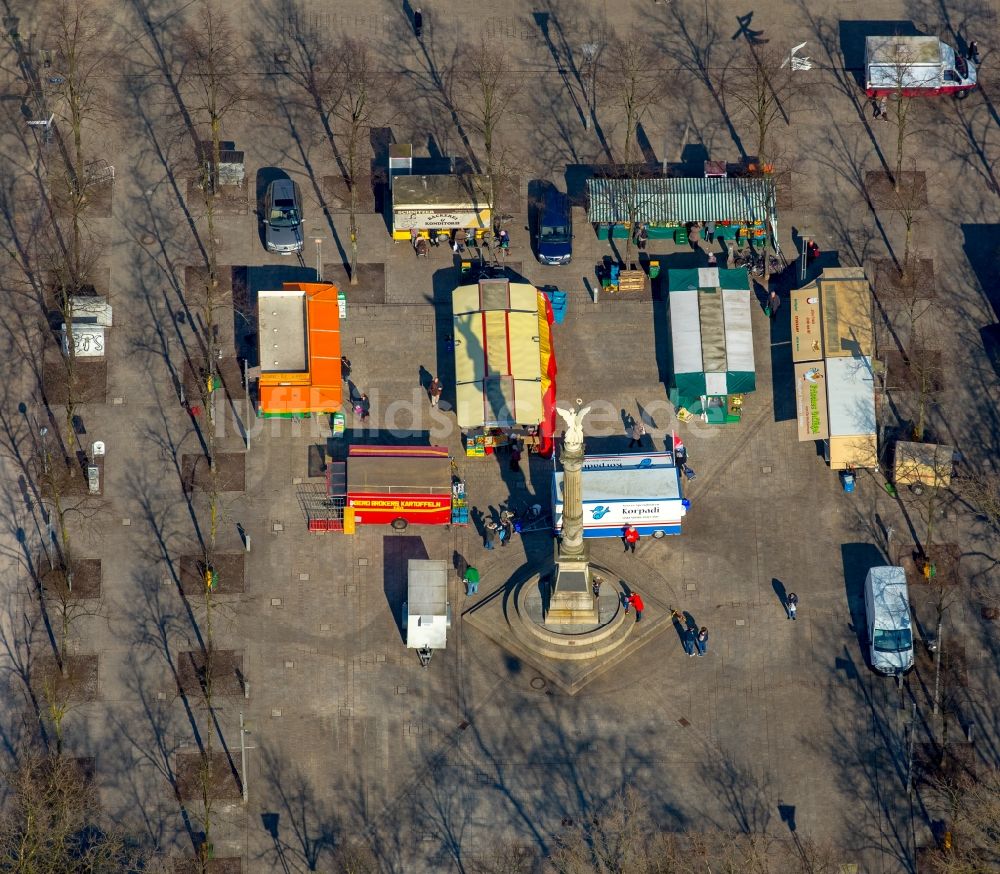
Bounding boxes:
[552,453,688,538]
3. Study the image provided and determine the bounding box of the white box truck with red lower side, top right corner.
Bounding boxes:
[865,36,976,97]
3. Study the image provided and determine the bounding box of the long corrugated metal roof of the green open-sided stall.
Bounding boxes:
[587,176,777,224]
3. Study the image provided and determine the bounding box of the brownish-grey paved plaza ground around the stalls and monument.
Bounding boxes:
[0,0,1000,874]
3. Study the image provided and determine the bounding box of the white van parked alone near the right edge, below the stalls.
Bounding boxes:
[865,567,913,674]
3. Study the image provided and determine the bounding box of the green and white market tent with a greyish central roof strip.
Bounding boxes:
[667,267,757,412]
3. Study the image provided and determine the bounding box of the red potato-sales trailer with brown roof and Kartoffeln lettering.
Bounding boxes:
[344,446,456,533]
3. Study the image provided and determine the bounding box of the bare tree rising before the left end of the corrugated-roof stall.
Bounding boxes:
[600,31,663,265]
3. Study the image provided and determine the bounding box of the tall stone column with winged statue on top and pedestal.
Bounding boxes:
[545,401,599,625]
